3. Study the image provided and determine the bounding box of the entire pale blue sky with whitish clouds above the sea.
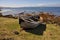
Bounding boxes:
[0,0,60,7]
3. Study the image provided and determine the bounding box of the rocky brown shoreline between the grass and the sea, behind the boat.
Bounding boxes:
[0,12,60,25]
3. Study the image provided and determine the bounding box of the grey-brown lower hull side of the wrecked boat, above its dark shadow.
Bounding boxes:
[20,22,40,28]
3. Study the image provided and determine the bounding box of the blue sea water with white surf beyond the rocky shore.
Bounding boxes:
[2,7,60,16]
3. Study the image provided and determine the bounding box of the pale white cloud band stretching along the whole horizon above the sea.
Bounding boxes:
[0,3,60,7]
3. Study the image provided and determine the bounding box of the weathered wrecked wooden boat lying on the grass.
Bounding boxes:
[19,14,44,29]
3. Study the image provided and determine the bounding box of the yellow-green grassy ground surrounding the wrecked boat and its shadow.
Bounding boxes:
[0,17,60,40]
